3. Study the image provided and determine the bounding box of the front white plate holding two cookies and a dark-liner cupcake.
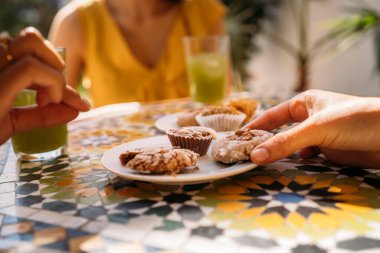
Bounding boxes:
[102,134,257,185]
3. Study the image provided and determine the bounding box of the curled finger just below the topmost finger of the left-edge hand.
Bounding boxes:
[0,56,65,108]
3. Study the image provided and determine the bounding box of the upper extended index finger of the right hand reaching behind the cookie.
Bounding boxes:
[245,96,308,131]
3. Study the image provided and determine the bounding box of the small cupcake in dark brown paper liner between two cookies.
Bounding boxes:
[166,126,216,156]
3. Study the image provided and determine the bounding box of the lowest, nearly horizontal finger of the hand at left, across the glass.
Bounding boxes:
[9,104,78,134]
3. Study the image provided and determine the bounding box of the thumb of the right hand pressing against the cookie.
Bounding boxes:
[251,120,322,164]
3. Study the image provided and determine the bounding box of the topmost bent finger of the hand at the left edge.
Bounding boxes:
[0,27,65,71]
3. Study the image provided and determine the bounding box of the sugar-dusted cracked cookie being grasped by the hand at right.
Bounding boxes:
[211,129,273,163]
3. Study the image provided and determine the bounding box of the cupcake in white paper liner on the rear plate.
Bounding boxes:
[195,106,246,132]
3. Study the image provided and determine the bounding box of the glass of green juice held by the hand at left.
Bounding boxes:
[12,48,67,161]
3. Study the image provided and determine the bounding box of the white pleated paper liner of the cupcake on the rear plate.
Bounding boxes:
[195,113,246,132]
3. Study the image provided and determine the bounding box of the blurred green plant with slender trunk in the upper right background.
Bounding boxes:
[265,0,380,91]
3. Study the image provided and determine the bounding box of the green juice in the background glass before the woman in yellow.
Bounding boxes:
[187,53,227,104]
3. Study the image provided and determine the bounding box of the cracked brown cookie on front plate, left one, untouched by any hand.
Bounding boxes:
[119,148,198,175]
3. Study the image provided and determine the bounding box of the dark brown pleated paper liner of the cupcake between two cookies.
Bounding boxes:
[168,134,212,156]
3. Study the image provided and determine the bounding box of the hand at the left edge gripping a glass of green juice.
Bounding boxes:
[0,28,90,144]
